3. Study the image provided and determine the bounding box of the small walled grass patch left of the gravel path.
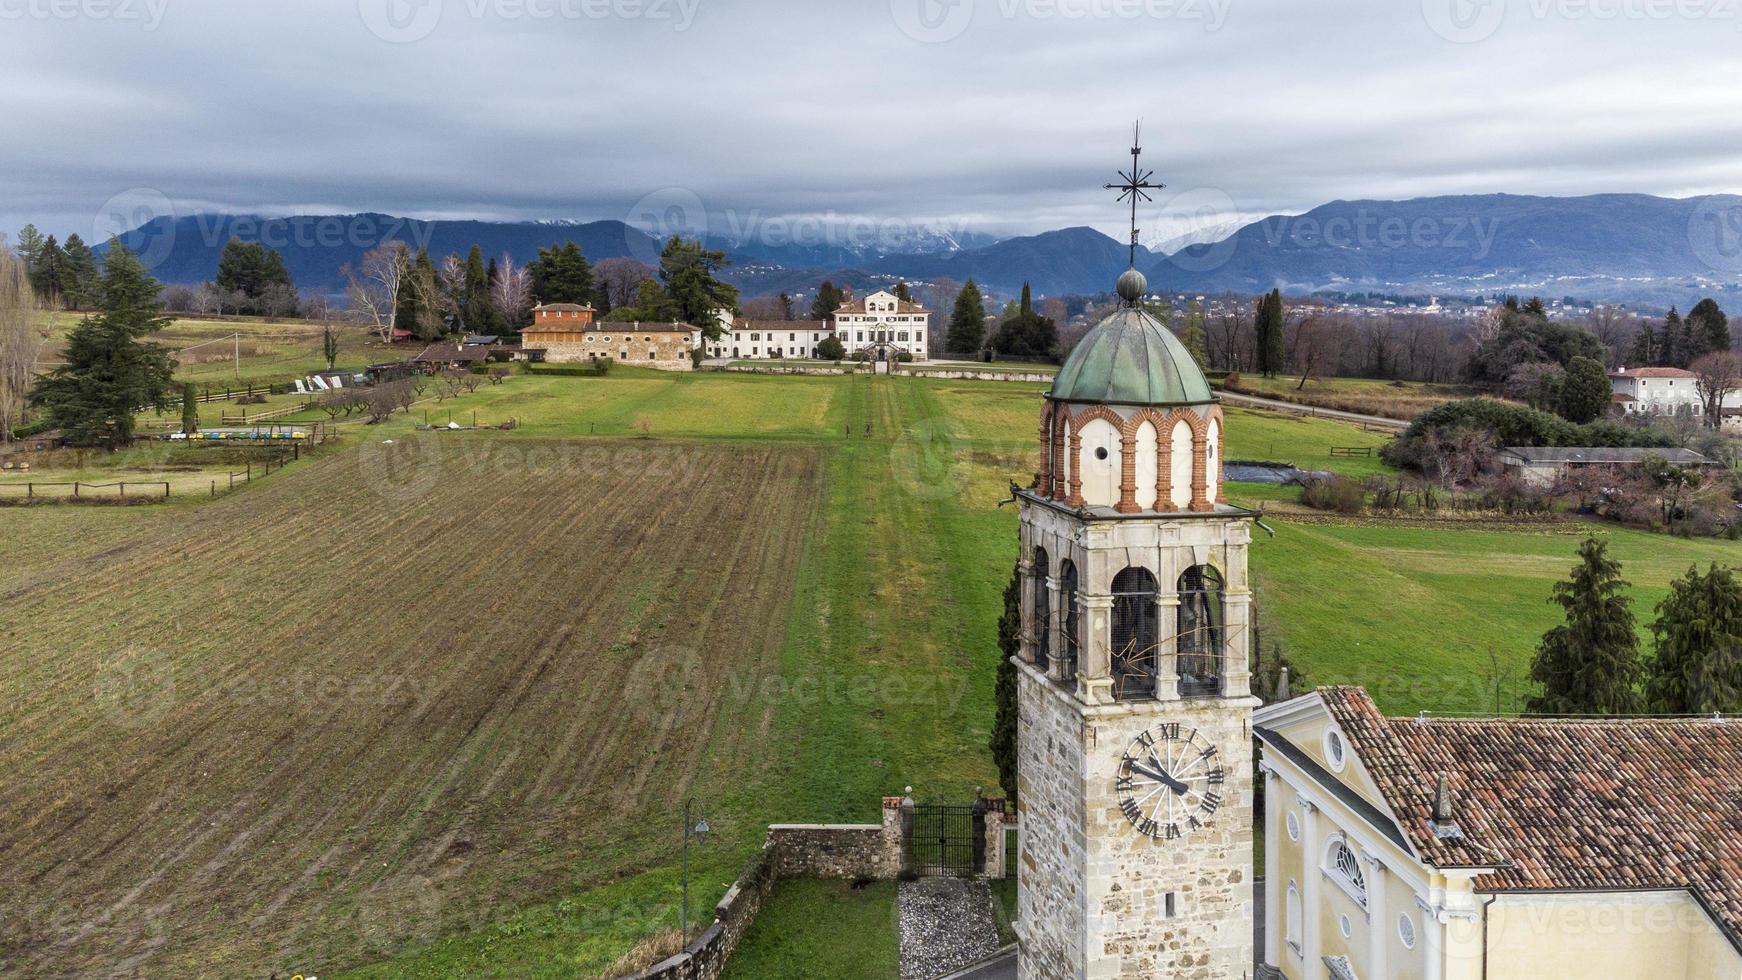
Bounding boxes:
[725,881,901,980]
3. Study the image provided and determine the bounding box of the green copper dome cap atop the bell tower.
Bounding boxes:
[1047,306,1216,406]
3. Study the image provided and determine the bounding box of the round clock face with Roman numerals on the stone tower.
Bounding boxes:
[1113,724,1226,841]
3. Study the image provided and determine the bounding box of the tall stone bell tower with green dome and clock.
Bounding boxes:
[1017,255,1258,980]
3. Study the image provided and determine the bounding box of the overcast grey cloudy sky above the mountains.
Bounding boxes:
[0,0,1742,248]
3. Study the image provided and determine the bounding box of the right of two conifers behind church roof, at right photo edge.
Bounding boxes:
[1644,567,1742,714]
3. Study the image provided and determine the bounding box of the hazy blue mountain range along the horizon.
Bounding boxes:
[112,193,1742,308]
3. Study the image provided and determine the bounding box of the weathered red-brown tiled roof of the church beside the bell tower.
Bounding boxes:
[1319,688,1742,945]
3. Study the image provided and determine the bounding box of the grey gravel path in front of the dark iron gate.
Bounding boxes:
[897,877,998,980]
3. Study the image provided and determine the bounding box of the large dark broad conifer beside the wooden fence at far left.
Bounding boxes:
[30,238,172,449]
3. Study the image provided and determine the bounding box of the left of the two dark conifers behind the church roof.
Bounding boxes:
[1529,538,1644,714]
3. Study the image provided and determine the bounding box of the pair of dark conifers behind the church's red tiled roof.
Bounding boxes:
[1528,538,1742,715]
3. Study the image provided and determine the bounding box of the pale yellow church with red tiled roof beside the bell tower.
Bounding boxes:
[1252,688,1742,980]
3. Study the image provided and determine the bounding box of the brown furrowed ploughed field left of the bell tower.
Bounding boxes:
[0,435,820,977]
